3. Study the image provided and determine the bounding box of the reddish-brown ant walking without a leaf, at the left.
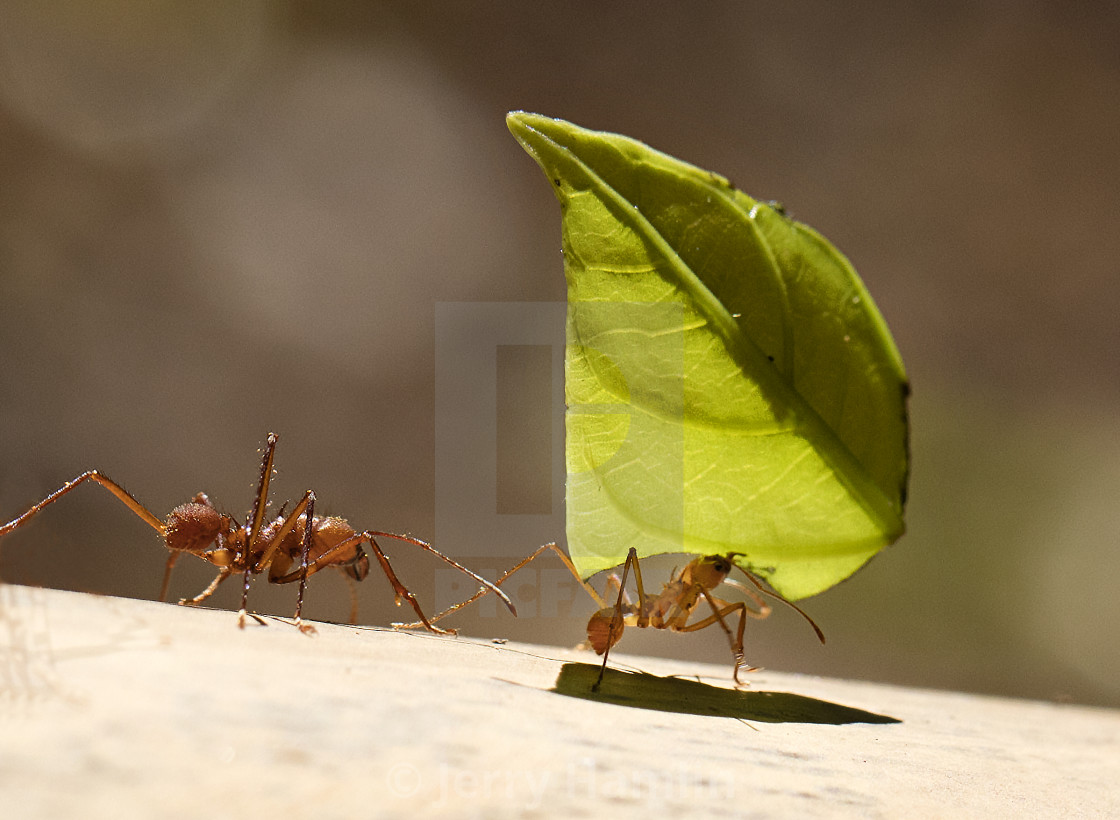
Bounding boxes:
[0,432,516,634]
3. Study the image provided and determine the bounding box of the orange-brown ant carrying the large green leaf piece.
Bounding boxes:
[403,543,824,691]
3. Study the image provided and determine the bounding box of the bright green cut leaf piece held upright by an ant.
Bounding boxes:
[507,112,908,599]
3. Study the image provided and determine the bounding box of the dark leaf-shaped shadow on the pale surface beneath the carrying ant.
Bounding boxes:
[550,663,902,726]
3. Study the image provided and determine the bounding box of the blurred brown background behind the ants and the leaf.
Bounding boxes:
[0,0,1120,705]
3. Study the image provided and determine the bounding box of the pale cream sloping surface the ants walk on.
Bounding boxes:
[0,586,1120,818]
